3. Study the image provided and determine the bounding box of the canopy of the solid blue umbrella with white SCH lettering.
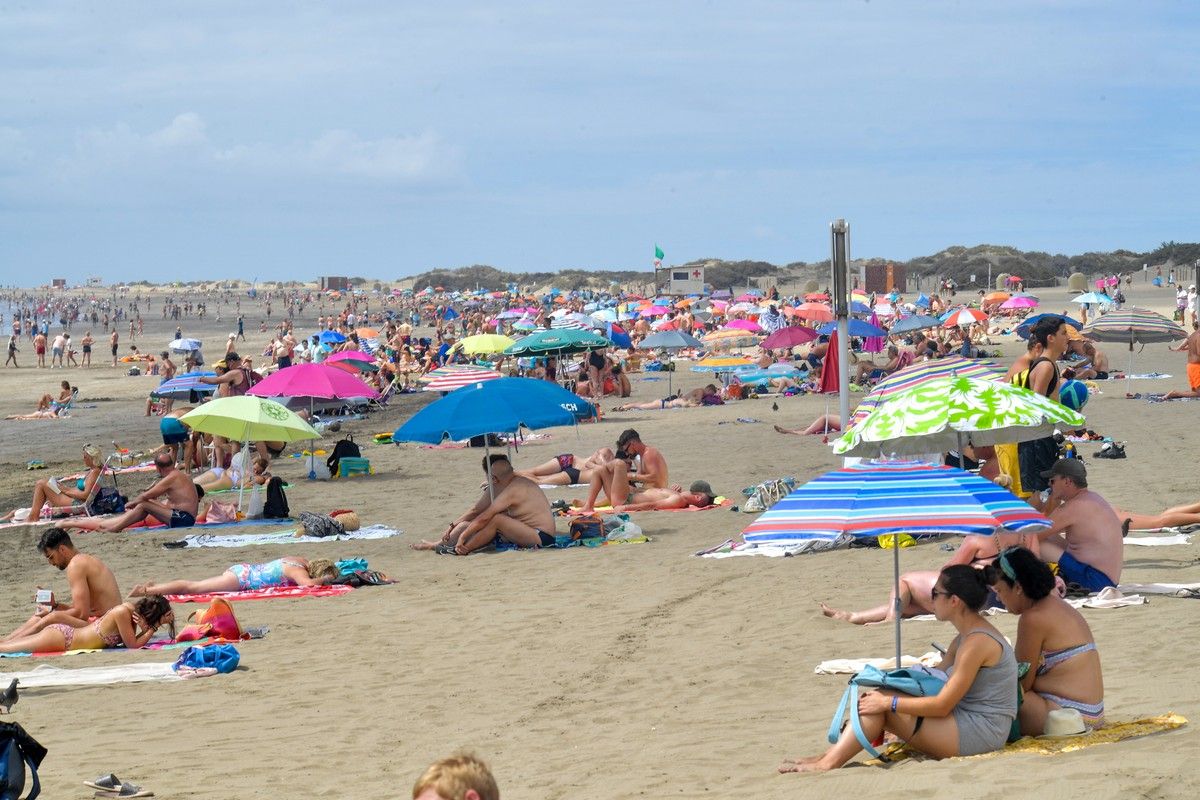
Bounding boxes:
[392,378,594,444]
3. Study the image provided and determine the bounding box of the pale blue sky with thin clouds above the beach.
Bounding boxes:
[0,0,1200,285]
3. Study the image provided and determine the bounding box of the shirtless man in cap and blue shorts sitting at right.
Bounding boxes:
[1036,458,1124,591]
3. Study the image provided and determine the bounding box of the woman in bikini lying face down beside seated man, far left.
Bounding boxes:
[0,594,175,652]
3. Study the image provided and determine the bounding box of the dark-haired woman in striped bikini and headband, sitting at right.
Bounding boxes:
[991,547,1104,736]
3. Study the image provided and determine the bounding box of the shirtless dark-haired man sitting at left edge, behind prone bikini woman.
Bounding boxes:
[2,528,121,642]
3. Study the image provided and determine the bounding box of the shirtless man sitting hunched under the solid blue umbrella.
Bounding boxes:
[412,453,554,555]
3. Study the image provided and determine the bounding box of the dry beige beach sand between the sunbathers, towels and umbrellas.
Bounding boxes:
[0,284,1200,800]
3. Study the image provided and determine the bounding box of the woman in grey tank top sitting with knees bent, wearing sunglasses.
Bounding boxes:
[779,565,1016,772]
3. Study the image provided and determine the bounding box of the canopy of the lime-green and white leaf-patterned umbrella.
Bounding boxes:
[833,377,1085,457]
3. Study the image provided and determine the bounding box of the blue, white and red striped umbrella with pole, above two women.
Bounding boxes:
[743,461,1050,663]
